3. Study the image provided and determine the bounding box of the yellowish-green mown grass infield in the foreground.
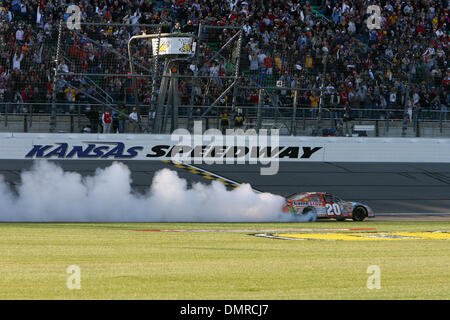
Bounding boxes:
[0,221,450,299]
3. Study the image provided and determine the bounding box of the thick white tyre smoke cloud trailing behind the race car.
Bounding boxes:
[0,161,315,222]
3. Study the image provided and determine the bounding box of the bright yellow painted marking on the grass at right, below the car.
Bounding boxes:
[255,231,450,241]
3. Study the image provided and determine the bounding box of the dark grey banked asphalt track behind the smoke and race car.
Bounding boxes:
[0,160,450,220]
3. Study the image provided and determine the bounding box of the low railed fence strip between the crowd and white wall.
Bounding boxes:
[0,103,450,137]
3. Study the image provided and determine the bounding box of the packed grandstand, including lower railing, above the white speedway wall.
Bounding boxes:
[0,0,450,136]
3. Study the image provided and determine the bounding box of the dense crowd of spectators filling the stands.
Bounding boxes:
[0,0,450,124]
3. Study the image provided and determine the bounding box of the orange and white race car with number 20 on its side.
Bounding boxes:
[283,192,375,221]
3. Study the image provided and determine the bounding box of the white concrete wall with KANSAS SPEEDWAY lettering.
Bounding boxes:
[0,133,450,163]
